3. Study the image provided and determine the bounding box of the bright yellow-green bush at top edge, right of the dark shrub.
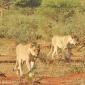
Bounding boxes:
[42,0,80,8]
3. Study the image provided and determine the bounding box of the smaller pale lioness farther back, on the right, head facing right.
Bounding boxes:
[49,35,76,59]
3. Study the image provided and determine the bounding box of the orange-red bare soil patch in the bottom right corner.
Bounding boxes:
[40,73,85,85]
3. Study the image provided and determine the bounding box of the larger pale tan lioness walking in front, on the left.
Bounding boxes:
[15,43,39,76]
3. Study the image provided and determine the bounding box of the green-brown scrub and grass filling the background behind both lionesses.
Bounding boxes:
[0,0,85,42]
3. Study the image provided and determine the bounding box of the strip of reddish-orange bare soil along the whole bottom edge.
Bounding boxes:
[0,73,85,85]
